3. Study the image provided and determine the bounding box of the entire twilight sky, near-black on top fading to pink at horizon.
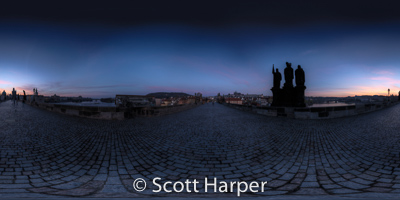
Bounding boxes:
[0,1,400,97]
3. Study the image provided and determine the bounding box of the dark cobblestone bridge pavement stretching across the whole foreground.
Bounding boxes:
[0,101,400,198]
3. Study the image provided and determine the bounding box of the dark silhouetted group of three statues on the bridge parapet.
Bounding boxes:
[271,62,306,107]
